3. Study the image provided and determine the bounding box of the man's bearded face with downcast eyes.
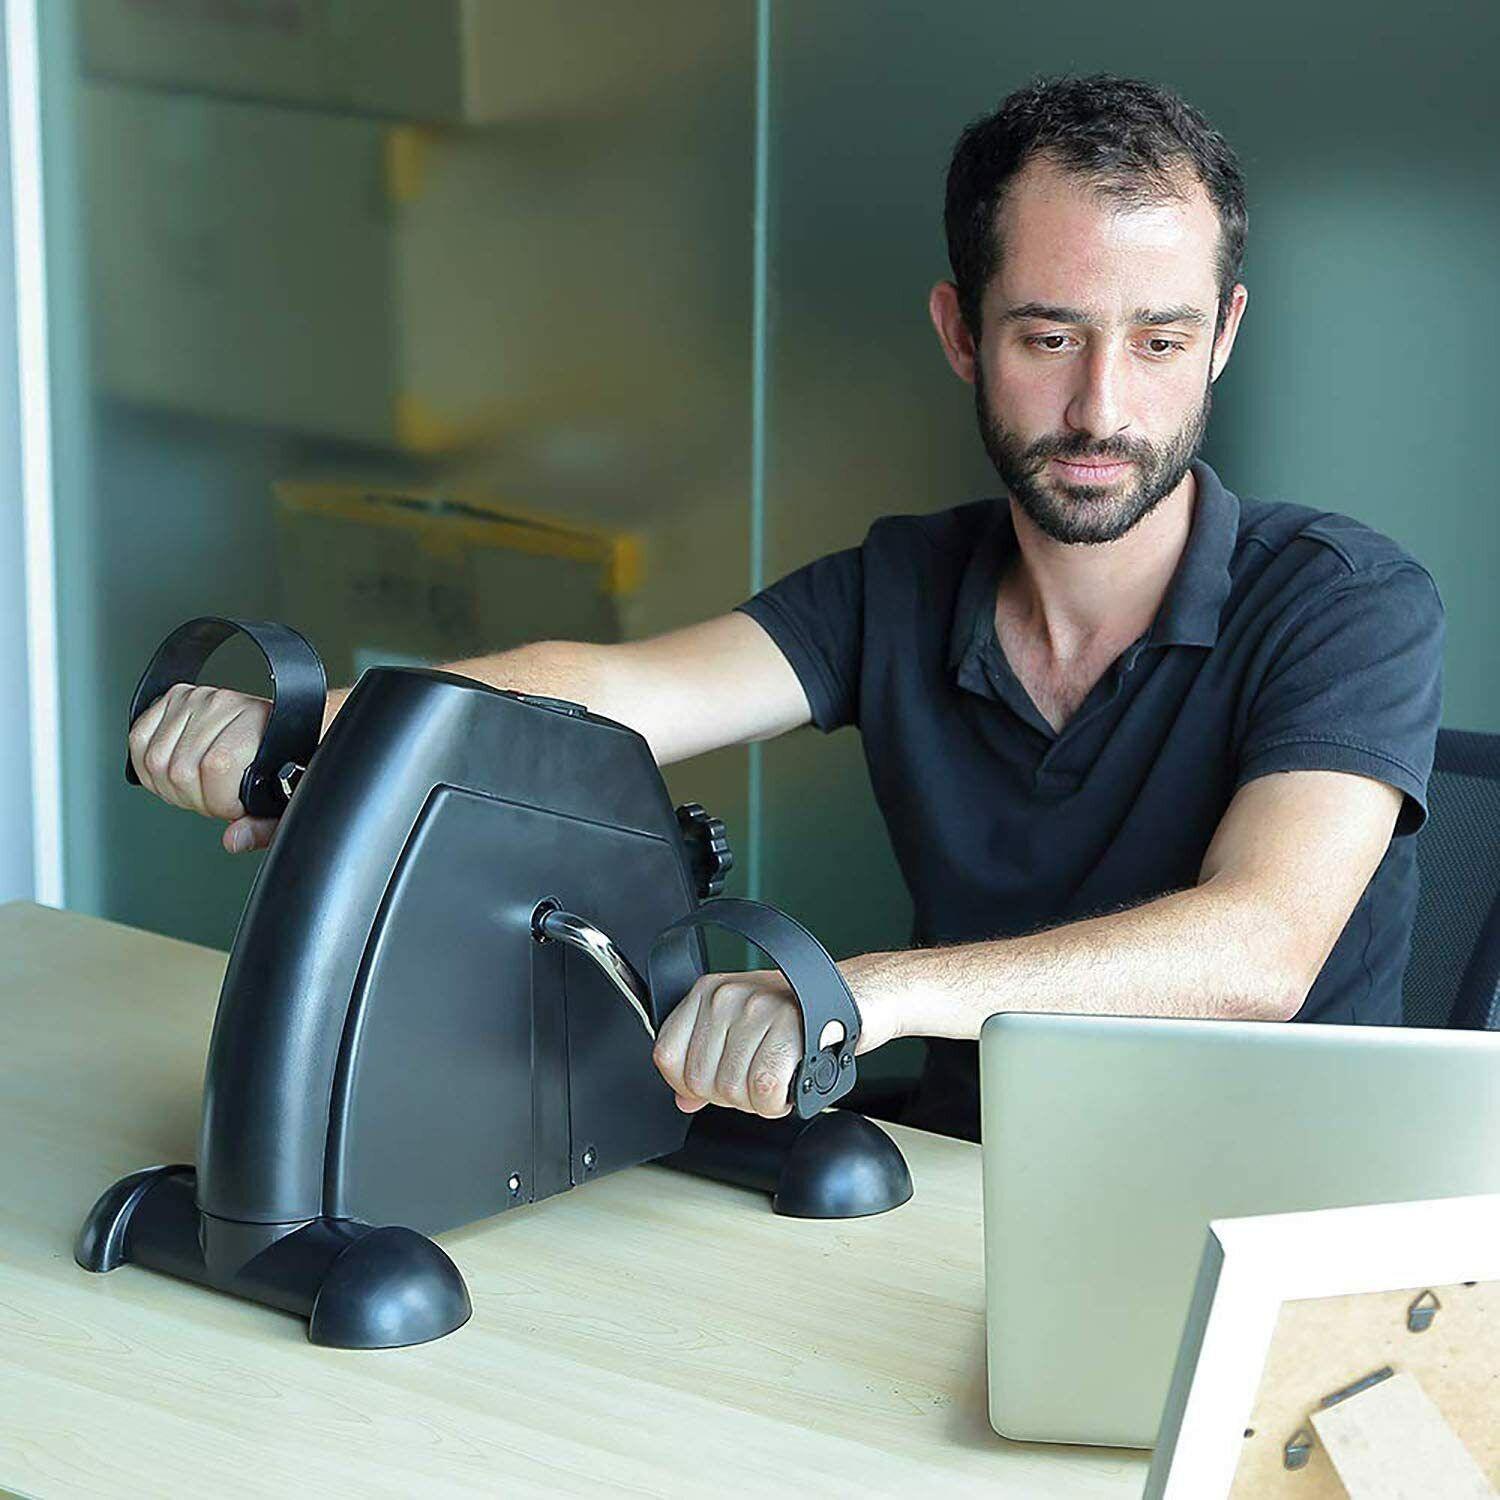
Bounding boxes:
[974,162,1241,543]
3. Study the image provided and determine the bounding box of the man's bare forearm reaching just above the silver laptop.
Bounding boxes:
[839,881,1311,1038]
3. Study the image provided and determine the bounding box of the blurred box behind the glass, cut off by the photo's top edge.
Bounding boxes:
[78,0,738,125]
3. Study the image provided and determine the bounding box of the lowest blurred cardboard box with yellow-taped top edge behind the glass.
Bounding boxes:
[275,480,644,686]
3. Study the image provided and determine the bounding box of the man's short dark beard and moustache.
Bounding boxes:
[974,362,1214,545]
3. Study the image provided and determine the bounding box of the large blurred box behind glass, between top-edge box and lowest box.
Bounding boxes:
[83,84,749,455]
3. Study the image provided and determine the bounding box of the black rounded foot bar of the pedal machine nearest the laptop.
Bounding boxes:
[662,1106,912,1218]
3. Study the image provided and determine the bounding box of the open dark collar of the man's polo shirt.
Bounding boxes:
[948,459,1239,683]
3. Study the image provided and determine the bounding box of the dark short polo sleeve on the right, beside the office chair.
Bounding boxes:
[1235,563,1445,836]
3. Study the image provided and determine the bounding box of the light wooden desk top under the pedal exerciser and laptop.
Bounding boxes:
[0,902,1146,1500]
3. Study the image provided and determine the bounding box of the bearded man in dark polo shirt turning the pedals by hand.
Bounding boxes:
[131,75,1443,1139]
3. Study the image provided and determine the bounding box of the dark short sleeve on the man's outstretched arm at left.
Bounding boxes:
[738,548,864,734]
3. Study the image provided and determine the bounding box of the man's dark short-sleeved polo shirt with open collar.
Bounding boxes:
[740,461,1443,1140]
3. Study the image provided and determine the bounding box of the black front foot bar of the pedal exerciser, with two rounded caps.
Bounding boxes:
[74,1166,473,1349]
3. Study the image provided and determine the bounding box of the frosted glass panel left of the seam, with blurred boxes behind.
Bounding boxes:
[42,0,755,947]
